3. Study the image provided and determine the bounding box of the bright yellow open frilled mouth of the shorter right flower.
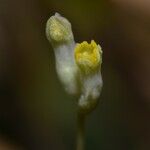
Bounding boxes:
[74,40,102,74]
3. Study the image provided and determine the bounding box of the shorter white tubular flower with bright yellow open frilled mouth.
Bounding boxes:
[74,40,103,113]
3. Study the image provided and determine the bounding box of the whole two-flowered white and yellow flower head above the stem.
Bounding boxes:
[46,13,103,113]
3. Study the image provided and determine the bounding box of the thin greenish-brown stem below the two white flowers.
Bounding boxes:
[76,112,85,150]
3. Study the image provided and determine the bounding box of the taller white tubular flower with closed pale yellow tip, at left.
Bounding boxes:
[46,13,78,94]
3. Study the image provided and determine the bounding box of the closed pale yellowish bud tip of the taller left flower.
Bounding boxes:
[46,13,73,42]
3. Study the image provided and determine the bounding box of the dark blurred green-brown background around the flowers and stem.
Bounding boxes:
[0,0,150,150]
